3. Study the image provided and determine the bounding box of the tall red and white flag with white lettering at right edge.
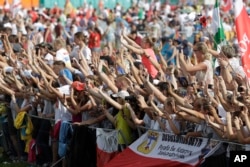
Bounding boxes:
[234,0,250,78]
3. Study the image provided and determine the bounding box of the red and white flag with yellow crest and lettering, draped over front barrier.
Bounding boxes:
[104,130,214,167]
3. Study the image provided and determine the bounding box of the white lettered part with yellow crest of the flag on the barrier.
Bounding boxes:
[129,130,208,166]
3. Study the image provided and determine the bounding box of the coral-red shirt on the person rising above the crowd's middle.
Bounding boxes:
[142,48,158,78]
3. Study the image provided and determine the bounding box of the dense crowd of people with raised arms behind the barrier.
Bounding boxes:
[0,1,250,165]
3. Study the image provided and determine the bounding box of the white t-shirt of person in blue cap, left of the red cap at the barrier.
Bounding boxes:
[54,85,72,122]
